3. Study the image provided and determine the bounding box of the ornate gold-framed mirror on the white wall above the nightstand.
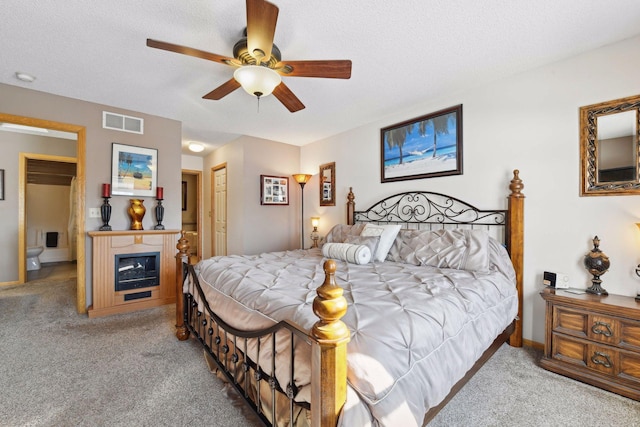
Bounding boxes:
[580,95,640,196]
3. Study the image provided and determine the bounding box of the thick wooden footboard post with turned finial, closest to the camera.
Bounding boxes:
[311,260,351,427]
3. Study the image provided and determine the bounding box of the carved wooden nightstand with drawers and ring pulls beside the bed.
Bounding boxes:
[540,288,640,400]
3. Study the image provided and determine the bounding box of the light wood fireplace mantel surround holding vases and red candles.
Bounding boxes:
[87,230,180,317]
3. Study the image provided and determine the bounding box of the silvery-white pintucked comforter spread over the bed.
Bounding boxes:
[185,242,518,427]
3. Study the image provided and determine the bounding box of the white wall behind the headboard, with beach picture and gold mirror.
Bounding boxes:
[301,37,640,343]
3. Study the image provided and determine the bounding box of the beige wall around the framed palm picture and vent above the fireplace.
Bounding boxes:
[0,84,182,305]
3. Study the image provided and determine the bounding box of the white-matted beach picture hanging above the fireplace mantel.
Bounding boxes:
[111,142,158,197]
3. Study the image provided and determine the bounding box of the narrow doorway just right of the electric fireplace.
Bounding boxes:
[181,169,202,261]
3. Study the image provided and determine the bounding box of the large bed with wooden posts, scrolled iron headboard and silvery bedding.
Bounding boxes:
[176,170,524,427]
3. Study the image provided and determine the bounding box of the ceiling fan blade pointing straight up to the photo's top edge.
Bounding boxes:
[247,0,278,64]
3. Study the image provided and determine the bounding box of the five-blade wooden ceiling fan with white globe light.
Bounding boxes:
[147,0,351,113]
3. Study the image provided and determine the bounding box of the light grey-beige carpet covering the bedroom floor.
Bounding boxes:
[0,280,640,427]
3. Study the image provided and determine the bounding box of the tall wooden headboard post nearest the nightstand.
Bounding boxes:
[507,169,524,347]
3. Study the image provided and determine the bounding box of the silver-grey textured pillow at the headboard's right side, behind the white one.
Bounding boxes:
[389,229,489,272]
